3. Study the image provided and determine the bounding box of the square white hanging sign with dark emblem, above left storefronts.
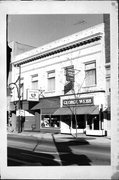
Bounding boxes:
[27,89,39,101]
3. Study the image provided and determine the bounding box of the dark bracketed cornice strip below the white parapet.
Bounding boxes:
[14,35,102,66]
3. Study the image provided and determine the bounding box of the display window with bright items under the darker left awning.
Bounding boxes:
[41,115,60,128]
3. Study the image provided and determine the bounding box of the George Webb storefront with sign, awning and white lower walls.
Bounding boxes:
[54,97,105,136]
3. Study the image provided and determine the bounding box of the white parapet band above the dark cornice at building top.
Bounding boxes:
[12,23,104,66]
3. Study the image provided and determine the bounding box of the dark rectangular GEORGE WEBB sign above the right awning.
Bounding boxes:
[63,97,93,106]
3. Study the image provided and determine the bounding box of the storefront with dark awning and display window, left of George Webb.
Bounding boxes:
[32,97,60,132]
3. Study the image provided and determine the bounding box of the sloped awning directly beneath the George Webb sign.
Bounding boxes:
[54,106,99,115]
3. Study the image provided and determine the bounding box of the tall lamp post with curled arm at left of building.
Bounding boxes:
[9,65,21,133]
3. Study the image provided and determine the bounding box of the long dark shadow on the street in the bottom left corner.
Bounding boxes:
[7,147,60,166]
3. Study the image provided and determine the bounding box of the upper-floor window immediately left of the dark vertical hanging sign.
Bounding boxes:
[47,71,55,91]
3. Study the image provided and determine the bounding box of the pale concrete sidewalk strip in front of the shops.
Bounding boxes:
[8,132,111,143]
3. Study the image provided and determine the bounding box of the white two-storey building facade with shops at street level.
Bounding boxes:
[10,23,110,136]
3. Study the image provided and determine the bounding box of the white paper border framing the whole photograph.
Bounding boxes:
[0,1,118,179]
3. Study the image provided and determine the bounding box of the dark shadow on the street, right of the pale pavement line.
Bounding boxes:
[52,134,91,166]
